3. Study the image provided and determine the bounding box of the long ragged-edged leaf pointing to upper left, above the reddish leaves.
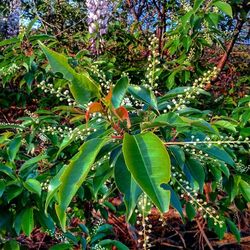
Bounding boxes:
[39,42,100,105]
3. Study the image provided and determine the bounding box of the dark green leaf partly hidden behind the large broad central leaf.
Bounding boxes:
[114,154,142,221]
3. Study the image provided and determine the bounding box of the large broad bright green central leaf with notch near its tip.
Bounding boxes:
[122,132,171,212]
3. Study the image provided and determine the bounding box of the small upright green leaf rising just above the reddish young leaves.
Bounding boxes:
[112,76,129,108]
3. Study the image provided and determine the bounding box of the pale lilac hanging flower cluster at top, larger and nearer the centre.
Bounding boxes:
[86,0,110,52]
